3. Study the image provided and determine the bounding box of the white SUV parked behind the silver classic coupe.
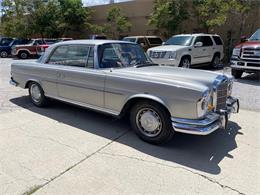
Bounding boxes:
[147,34,224,68]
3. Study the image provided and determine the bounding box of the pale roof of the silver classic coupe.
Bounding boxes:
[56,39,135,45]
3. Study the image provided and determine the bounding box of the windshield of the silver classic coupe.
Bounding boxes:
[99,43,152,68]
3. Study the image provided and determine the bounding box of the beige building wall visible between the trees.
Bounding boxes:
[88,0,260,58]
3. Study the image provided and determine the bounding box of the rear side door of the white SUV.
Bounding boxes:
[192,36,213,64]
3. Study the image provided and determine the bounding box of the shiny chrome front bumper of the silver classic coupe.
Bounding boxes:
[172,97,239,135]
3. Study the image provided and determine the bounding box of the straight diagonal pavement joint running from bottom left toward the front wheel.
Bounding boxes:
[23,130,129,195]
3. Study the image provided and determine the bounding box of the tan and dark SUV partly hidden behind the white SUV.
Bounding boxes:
[123,36,163,51]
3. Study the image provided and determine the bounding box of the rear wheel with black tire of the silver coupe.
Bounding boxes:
[28,82,47,107]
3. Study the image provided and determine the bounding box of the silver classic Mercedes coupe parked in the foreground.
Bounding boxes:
[10,40,239,144]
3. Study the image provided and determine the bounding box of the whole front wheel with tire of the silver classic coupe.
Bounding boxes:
[130,101,174,144]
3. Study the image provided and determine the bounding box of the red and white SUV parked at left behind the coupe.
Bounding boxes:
[12,39,49,59]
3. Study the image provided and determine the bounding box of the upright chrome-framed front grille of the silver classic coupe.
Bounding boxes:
[216,80,228,110]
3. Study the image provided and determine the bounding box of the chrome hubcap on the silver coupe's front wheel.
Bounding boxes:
[136,108,162,137]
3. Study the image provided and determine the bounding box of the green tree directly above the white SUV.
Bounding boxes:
[148,0,189,36]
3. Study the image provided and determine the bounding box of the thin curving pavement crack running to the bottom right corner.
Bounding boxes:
[99,152,245,195]
